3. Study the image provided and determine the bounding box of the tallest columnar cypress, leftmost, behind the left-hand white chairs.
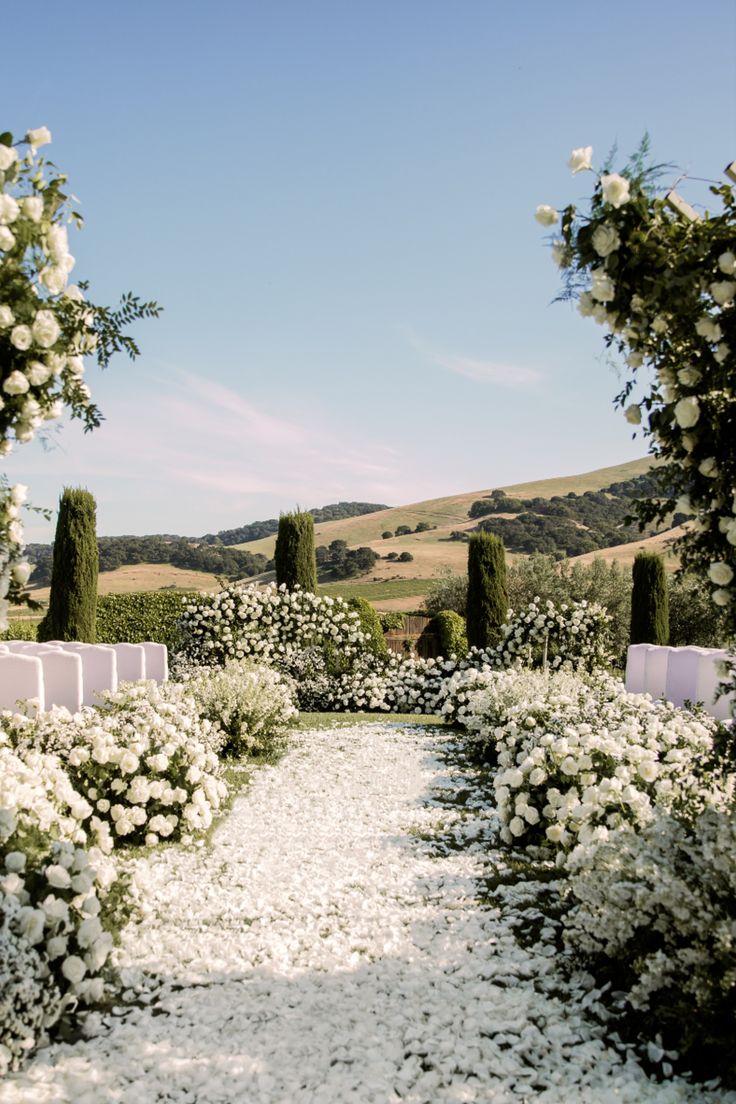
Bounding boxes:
[38,487,99,644]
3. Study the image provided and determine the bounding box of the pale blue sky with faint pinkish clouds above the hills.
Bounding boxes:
[0,0,736,540]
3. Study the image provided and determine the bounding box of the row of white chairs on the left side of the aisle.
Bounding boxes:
[0,640,169,713]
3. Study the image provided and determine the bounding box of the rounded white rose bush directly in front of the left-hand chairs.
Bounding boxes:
[8,681,226,846]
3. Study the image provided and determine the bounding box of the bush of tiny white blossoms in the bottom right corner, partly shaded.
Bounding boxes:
[564,806,736,1079]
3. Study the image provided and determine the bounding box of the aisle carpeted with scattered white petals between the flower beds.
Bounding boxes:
[0,722,736,1104]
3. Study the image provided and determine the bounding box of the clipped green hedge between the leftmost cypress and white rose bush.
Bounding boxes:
[97,591,198,651]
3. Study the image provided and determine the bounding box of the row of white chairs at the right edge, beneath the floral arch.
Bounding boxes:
[626,644,734,721]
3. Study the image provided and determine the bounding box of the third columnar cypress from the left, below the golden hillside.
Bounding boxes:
[467,531,509,648]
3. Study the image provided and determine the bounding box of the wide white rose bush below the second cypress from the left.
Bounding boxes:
[181,583,366,673]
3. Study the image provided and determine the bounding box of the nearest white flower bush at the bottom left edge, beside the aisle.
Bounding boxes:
[0,741,131,1072]
